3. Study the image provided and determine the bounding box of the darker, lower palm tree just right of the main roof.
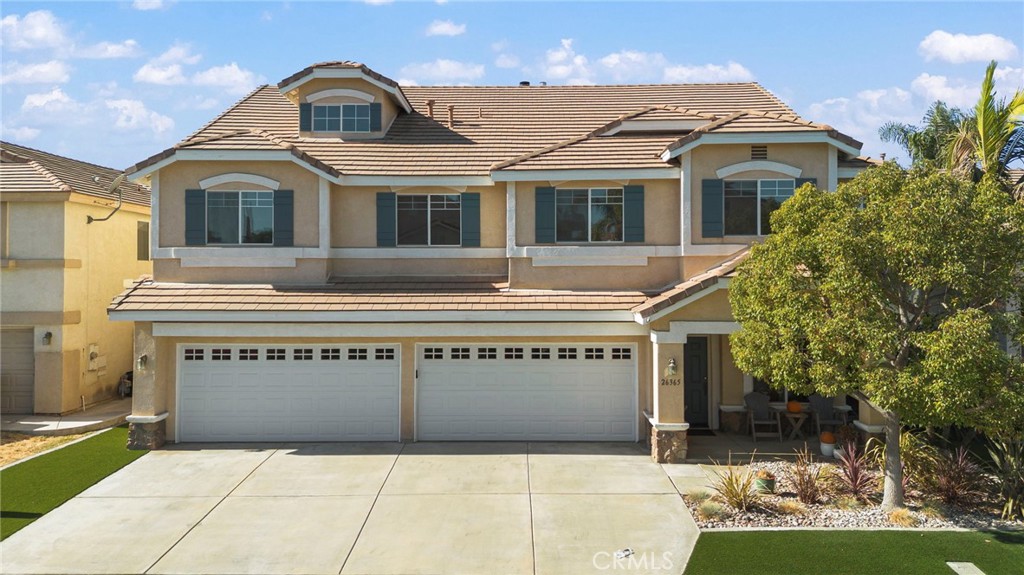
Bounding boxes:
[879,100,966,165]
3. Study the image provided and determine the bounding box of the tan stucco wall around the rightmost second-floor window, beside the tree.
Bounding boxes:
[689,143,828,244]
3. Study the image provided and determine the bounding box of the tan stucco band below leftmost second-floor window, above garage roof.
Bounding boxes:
[153,259,328,283]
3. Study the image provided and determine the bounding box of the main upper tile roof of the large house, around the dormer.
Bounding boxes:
[129,76,806,176]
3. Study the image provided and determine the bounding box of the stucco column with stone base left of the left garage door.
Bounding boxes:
[128,322,165,449]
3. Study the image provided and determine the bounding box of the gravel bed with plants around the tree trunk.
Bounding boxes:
[684,461,1024,530]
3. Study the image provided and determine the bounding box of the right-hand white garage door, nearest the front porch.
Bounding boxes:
[416,344,637,441]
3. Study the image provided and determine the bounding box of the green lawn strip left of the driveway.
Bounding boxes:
[0,427,146,539]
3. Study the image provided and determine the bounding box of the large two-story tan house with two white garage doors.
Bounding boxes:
[110,62,868,459]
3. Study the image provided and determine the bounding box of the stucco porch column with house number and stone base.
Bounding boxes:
[650,342,687,463]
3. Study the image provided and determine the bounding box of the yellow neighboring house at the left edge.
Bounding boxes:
[0,142,152,414]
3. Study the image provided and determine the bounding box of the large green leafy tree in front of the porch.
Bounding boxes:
[729,162,1024,510]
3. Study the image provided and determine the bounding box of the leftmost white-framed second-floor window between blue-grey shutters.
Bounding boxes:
[206,190,273,245]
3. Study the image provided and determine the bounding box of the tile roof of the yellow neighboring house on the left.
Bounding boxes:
[0,142,150,206]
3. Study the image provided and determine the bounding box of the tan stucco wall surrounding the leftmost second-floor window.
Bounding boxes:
[160,162,319,248]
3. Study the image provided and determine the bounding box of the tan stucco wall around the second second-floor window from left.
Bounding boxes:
[331,186,505,248]
